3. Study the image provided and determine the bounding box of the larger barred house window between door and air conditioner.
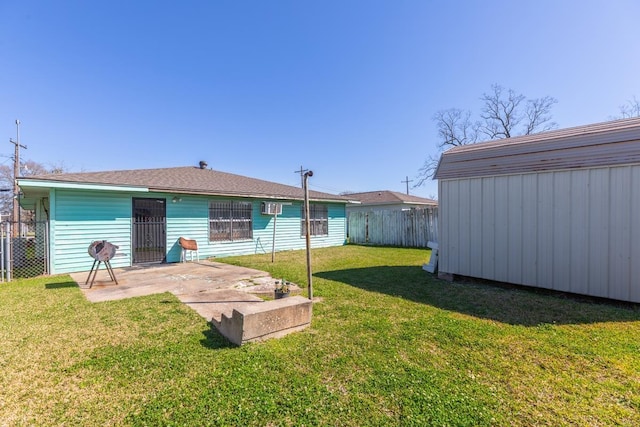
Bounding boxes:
[209,201,253,242]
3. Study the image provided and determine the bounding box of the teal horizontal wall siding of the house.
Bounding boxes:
[50,189,346,273]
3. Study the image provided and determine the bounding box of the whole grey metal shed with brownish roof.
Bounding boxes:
[435,118,640,302]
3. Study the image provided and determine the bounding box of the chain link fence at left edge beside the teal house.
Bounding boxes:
[0,221,49,281]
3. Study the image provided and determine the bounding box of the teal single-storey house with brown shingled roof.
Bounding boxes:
[18,162,348,274]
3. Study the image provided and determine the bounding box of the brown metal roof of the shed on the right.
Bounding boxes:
[434,118,640,179]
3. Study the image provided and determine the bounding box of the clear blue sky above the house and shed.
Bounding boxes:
[0,0,640,197]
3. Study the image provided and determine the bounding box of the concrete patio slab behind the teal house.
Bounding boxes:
[71,261,300,325]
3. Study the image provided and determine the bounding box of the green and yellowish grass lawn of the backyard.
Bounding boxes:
[0,245,640,427]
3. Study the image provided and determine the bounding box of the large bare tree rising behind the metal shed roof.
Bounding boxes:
[414,84,558,187]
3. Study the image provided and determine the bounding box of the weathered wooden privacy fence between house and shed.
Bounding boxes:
[347,208,438,248]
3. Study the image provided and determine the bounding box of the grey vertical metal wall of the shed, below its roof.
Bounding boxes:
[439,165,640,302]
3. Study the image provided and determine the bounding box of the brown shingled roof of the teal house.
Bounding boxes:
[18,166,348,203]
